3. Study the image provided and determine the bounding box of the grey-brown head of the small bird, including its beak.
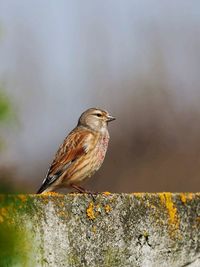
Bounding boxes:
[78,108,115,131]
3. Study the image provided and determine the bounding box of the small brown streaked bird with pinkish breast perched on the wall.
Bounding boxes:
[37,108,115,194]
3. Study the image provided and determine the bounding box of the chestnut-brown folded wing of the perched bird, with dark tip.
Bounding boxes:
[37,128,93,194]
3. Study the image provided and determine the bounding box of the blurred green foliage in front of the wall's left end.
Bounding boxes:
[0,198,34,267]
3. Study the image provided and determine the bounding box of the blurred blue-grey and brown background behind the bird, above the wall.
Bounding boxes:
[0,0,200,193]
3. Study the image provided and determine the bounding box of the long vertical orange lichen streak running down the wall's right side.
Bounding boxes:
[159,193,180,236]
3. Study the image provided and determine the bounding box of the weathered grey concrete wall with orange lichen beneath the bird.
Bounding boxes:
[0,193,200,267]
